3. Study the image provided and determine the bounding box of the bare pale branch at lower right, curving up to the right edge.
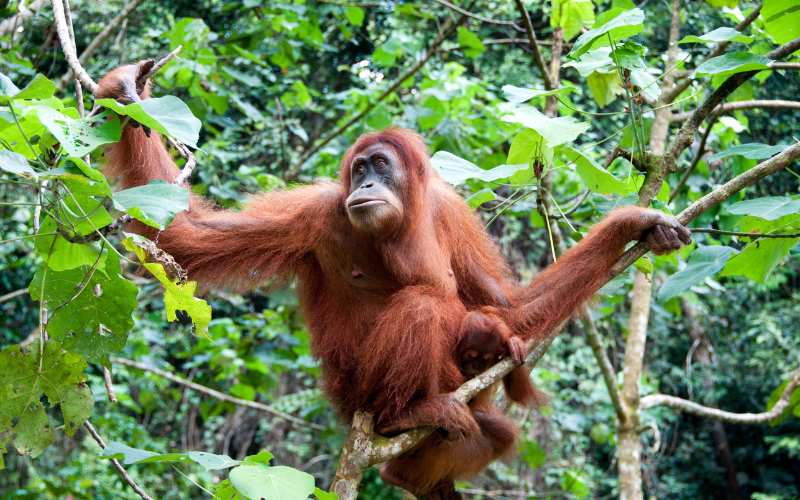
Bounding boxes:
[642,371,800,425]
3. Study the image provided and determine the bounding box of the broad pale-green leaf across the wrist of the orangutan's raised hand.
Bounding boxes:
[95,95,201,148]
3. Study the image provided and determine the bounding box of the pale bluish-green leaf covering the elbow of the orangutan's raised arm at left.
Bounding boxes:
[113,180,189,229]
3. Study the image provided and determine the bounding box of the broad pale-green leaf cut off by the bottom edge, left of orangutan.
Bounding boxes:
[229,464,314,500]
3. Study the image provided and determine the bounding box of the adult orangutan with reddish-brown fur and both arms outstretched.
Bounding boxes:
[97,62,689,498]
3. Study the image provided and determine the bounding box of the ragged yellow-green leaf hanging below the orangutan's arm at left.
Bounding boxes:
[122,238,211,335]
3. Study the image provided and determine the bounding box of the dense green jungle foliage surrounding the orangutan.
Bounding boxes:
[0,0,800,499]
